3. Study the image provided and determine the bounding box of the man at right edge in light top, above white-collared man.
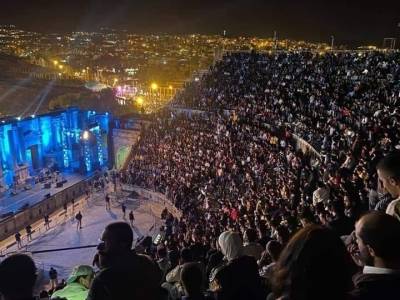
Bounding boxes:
[376,151,400,220]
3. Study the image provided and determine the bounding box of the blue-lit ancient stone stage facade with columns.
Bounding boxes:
[0,108,111,187]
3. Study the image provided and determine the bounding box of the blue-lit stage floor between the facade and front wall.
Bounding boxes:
[0,173,88,219]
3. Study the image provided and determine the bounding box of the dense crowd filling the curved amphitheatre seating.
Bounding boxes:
[0,52,400,300]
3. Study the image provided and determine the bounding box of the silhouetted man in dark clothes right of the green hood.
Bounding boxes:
[87,222,161,300]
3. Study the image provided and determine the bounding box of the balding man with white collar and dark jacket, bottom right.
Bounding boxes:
[352,212,400,300]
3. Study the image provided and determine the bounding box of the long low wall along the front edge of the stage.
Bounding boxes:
[0,179,89,241]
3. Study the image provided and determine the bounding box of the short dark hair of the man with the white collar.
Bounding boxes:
[358,211,400,260]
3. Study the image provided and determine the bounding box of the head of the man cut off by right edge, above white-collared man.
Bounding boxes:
[376,151,400,198]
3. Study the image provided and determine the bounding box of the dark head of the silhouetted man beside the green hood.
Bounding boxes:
[101,222,133,254]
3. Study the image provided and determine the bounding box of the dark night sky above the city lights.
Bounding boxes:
[0,0,400,45]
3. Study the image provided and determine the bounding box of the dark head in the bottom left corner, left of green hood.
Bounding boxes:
[0,254,37,300]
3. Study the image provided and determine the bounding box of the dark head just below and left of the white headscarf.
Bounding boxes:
[181,263,203,296]
